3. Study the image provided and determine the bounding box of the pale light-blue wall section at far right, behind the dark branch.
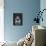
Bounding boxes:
[40,0,46,26]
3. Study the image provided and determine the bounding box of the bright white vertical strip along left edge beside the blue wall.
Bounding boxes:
[0,0,4,42]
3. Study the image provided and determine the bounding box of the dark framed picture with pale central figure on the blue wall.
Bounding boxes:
[13,13,23,25]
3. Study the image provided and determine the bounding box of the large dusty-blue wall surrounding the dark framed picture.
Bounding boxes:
[4,0,40,41]
